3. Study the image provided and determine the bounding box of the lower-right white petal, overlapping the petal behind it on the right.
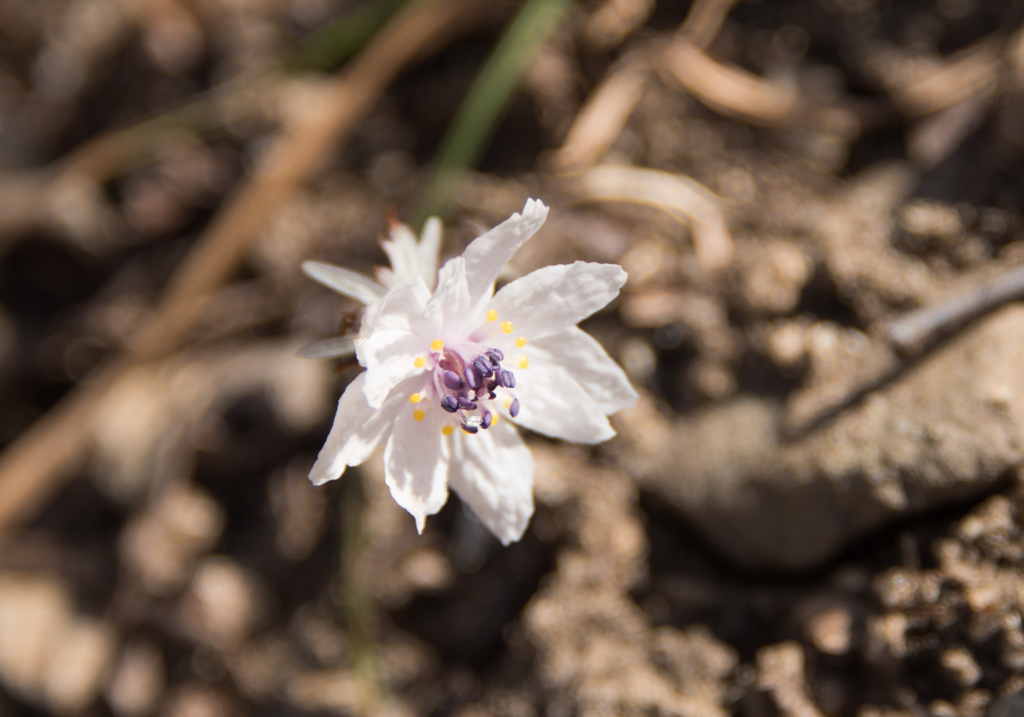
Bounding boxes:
[512,356,615,444]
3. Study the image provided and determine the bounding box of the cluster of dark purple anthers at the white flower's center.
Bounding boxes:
[433,345,519,433]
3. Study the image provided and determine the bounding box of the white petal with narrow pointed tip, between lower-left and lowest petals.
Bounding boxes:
[384,399,450,533]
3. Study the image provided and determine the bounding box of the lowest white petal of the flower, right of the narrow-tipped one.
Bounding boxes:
[449,421,534,545]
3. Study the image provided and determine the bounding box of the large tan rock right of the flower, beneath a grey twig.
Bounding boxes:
[616,305,1024,570]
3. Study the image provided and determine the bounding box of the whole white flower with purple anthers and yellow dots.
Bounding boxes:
[305,200,637,544]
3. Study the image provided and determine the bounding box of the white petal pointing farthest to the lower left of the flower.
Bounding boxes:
[309,373,415,486]
